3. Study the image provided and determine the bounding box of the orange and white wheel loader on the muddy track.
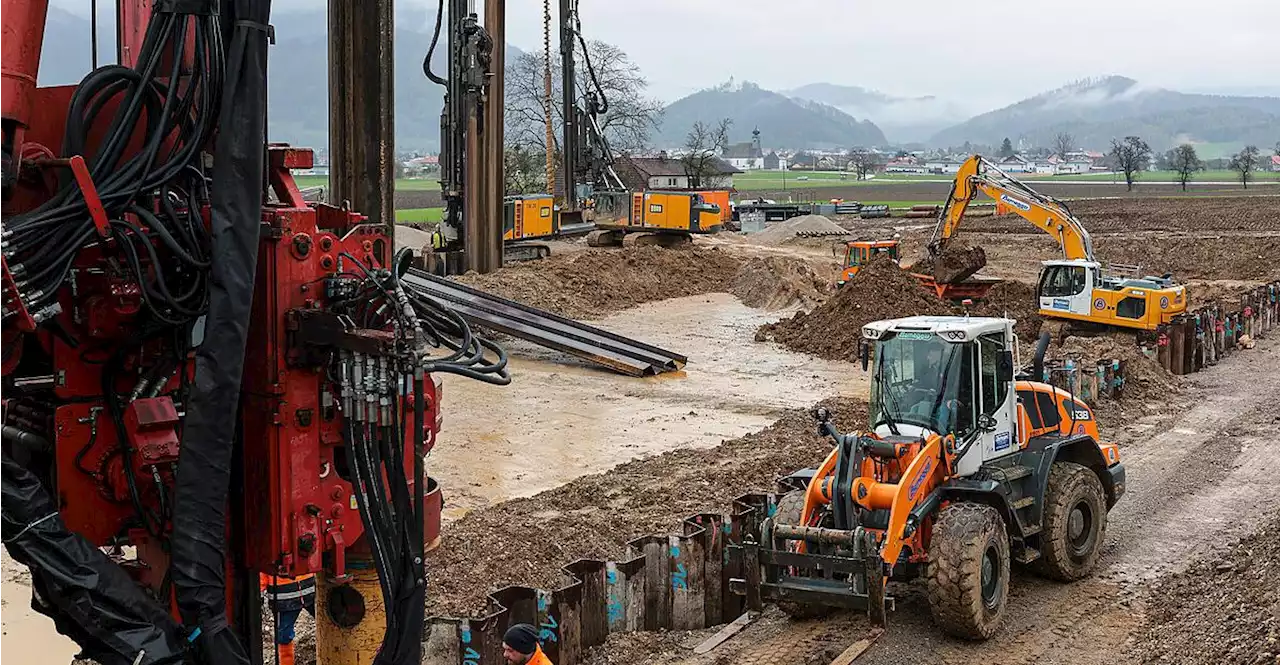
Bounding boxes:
[732,317,1125,639]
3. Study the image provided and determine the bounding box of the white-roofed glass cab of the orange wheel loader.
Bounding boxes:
[863,316,1018,474]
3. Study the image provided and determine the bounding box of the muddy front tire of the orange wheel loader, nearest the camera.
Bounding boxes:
[928,503,1009,639]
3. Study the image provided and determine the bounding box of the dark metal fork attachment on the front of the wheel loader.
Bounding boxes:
[730,501,893,628]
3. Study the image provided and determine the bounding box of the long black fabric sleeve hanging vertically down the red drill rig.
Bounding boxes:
[173,0,271,665]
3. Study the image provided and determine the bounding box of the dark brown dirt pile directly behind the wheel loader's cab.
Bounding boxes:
[755,258,954,362]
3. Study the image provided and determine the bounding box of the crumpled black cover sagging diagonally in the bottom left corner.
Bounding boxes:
[0,451,183,665]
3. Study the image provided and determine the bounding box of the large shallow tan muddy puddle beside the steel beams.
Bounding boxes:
[430,294,867,519]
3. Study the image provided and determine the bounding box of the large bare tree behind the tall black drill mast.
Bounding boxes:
[506,41,663,155]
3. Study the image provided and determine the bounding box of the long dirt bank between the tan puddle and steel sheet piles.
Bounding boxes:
[426,398,867,616]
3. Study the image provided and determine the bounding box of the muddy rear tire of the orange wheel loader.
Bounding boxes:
[1032,462,1107,582]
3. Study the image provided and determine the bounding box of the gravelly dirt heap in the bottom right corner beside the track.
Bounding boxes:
[1134,518,1280,665]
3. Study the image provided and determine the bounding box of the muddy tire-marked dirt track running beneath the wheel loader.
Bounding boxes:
[586,340,1280,665]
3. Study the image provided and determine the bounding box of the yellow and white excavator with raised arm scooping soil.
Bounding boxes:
[929,155,1187,330]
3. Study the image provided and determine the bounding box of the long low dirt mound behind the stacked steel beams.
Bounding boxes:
[457,247,741,318]
